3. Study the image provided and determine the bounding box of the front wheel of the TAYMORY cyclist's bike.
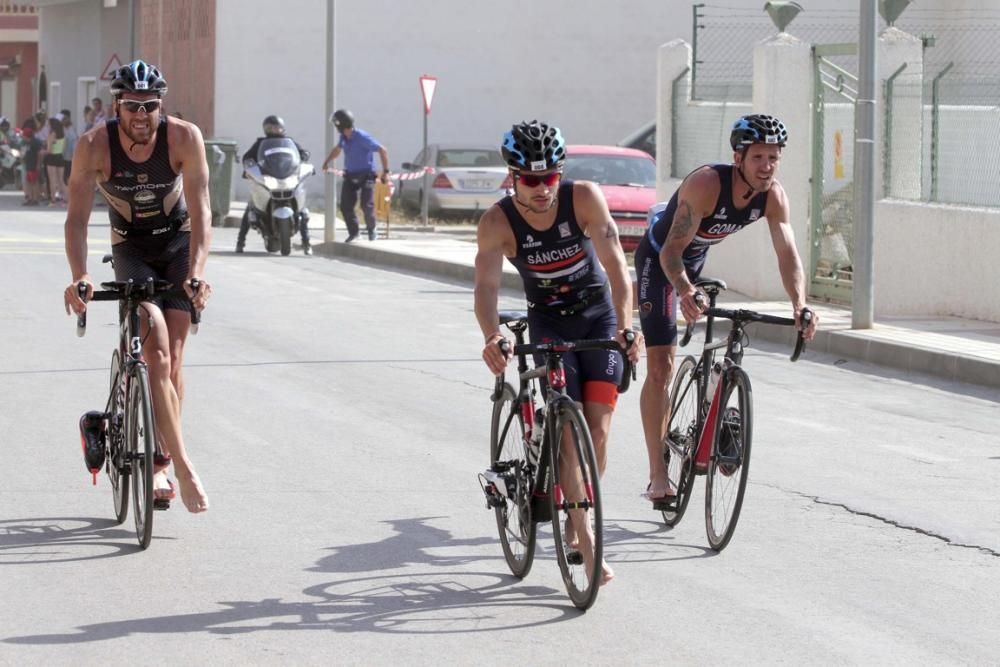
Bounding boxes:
[125,364,156,549]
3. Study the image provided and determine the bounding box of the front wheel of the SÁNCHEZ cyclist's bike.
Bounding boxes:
[548,398,604,609]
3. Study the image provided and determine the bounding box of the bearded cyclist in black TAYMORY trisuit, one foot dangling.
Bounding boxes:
[63,60,212,512]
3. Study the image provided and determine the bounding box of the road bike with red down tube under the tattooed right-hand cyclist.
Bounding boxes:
[653,278,813,551]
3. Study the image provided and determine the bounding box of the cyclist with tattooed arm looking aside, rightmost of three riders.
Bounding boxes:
[635,114,819,503]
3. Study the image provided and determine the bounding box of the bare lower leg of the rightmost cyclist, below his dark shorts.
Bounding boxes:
[639,345,677,498]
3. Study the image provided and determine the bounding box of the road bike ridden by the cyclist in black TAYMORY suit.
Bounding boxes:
[76,255,200,549]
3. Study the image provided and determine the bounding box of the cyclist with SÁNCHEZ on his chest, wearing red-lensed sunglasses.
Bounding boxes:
[475,121,642,584]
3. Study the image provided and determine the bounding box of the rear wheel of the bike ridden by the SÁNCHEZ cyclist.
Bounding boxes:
[490,384,538,578]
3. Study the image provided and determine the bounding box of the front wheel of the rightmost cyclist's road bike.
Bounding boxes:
[705,368,753,551]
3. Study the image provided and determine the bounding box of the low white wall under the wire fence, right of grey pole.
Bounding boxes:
[873,199,1000,322]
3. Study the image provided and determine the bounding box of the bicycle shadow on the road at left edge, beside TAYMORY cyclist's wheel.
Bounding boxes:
[0,517,166,566]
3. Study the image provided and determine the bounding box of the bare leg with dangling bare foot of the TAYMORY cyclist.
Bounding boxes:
[143,304,208,513]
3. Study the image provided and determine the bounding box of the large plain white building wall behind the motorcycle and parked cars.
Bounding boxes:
[215,0,708,201]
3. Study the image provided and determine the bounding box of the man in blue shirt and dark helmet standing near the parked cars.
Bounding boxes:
[323,109,389,243]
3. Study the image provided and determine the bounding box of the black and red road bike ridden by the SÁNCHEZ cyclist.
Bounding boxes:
[480,312,634,609]
